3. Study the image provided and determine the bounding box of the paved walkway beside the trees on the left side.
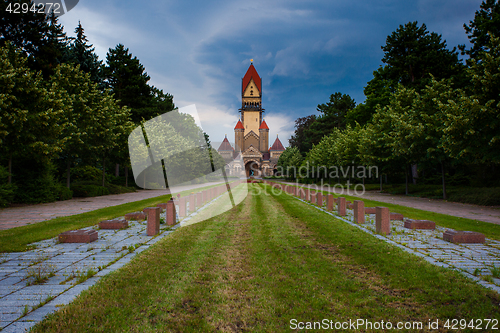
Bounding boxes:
[0,183,225,230]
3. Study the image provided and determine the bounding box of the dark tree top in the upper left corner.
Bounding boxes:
[0,0,67,78]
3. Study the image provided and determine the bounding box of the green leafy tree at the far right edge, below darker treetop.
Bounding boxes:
[441,36,500,163]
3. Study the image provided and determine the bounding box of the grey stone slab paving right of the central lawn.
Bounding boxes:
[294,189,500,293]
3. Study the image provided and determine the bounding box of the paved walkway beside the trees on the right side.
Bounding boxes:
[283,182,500,225]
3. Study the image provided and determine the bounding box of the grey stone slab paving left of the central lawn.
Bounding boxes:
[0,213,179,333]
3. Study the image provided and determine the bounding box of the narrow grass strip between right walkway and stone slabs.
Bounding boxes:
[280,184,500,240]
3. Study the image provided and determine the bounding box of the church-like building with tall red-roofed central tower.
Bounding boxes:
[218,64,285,177]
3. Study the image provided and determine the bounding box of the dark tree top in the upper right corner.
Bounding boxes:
[458,0,500,59]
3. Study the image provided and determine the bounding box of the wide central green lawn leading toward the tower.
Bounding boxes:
[33,184,500,332]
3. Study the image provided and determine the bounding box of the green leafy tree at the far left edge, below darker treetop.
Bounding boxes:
[0,44,68,183]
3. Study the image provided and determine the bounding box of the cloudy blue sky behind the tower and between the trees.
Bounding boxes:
[60,0,481,146]
